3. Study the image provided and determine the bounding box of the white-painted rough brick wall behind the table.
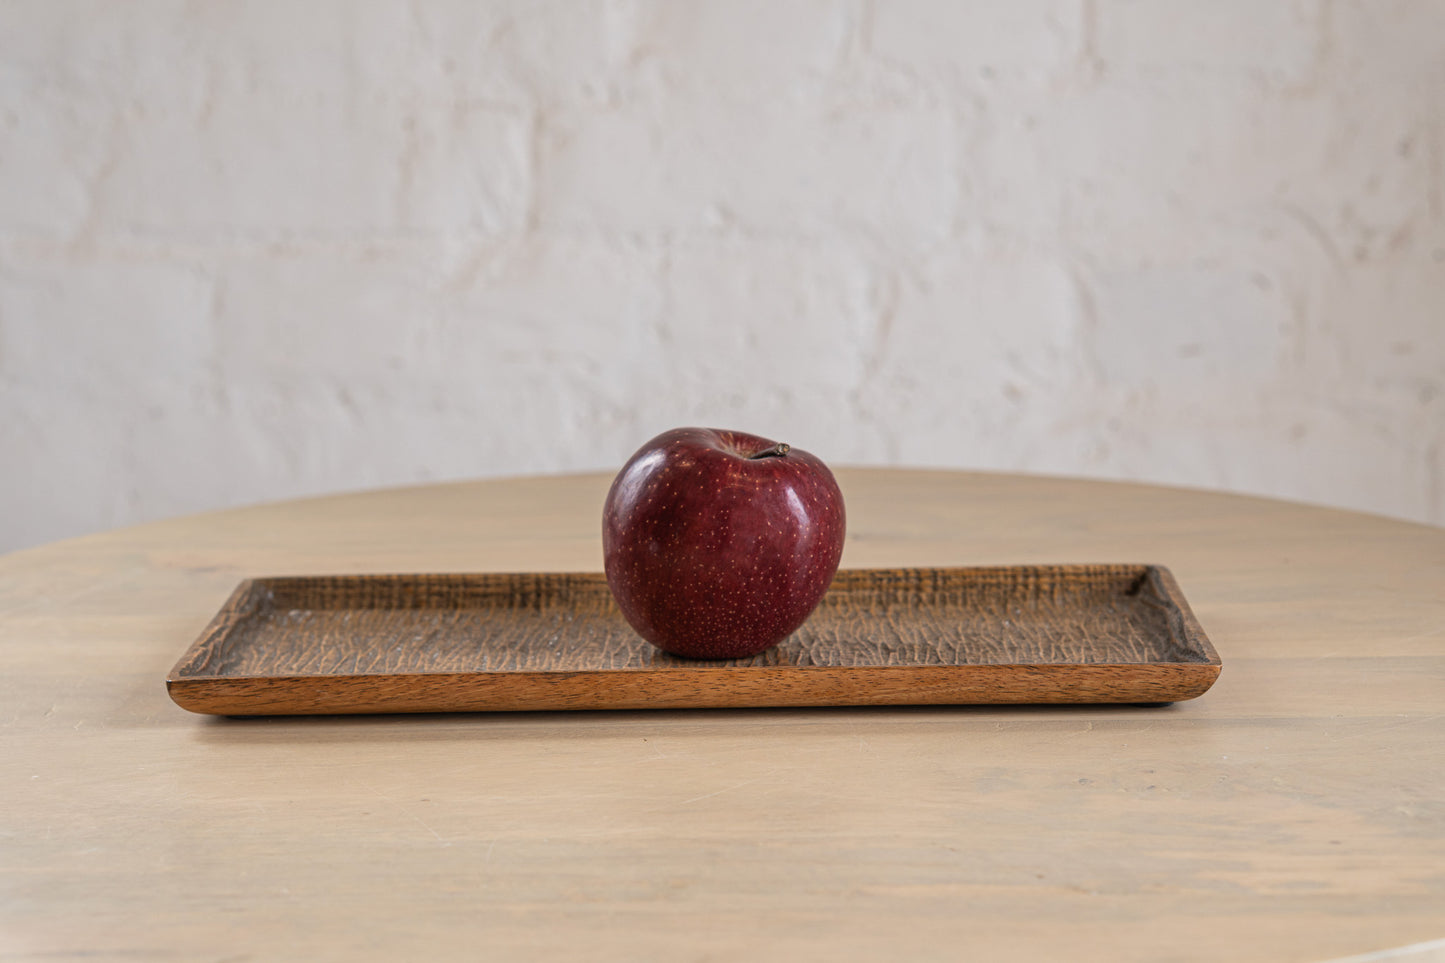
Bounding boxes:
[0,0,1445,551]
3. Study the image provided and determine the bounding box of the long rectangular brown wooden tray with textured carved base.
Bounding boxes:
[166,565,1220,716]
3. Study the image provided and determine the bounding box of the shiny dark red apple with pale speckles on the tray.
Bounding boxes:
[603,428,845,659]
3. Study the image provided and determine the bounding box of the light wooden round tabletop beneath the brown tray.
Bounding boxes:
[0,470,1445,963]
